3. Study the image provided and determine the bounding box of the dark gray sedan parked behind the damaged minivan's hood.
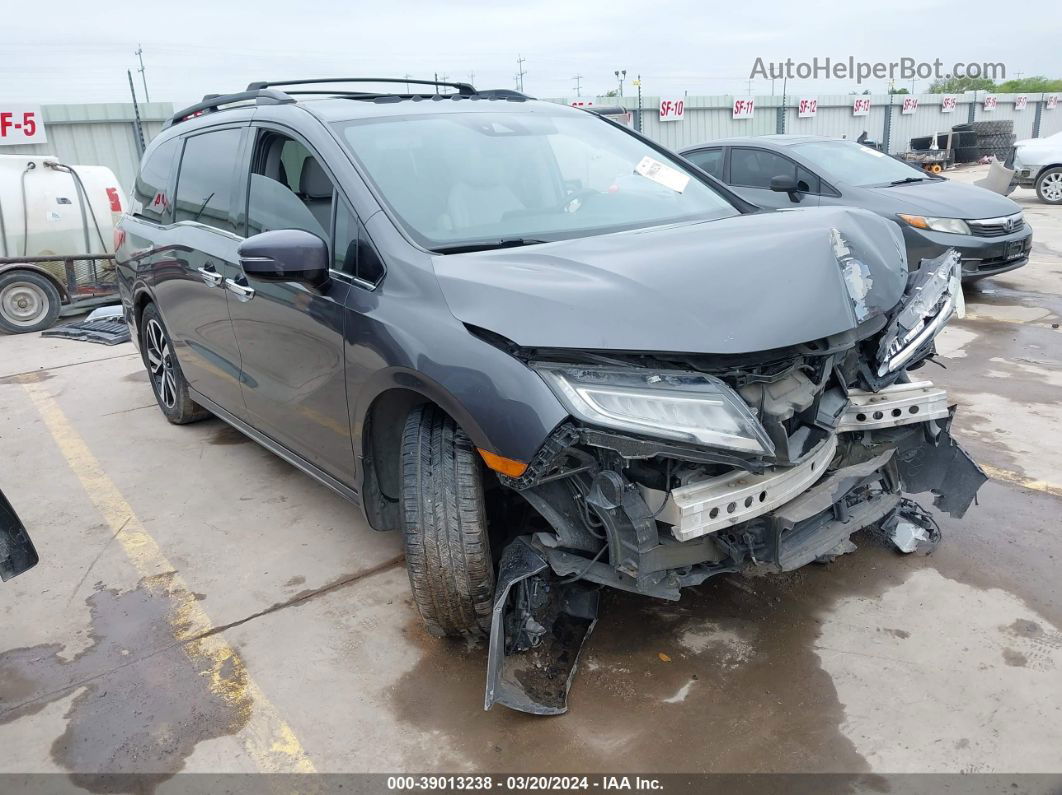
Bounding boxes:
[682,135,1032,281]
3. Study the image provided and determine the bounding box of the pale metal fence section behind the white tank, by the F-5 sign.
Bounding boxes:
[0,102,173,193]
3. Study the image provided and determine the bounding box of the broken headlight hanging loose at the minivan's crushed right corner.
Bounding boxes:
[877,248,965,378]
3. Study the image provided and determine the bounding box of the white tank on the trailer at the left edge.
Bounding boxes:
[0,155,125,258]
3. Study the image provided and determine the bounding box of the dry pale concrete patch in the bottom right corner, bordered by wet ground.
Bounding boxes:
[817,569,1062,773]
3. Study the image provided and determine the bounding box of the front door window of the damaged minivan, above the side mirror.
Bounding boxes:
[247,132,335,241]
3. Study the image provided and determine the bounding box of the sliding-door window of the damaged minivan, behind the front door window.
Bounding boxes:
[174,129,242,231]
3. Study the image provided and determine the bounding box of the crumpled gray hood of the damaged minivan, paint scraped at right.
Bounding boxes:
[433,207,907,353]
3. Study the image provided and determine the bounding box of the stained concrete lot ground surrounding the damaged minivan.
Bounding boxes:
[0,164,1062,791]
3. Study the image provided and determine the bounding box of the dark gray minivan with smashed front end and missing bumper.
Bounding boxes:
[116,79,984,714]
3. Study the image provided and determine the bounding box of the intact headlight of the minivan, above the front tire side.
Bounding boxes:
[533,363,774,454]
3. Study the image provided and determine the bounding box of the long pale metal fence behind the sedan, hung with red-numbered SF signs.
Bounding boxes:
[549,91,1062,154]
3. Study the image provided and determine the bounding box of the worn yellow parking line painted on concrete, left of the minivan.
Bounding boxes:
[20,374,315,773]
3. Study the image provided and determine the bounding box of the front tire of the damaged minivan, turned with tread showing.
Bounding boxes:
[401,404,495,638]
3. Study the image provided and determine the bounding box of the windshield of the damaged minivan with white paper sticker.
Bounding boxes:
[339,113,738,249]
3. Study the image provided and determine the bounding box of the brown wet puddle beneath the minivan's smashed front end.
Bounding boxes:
[391,536,943,773]
